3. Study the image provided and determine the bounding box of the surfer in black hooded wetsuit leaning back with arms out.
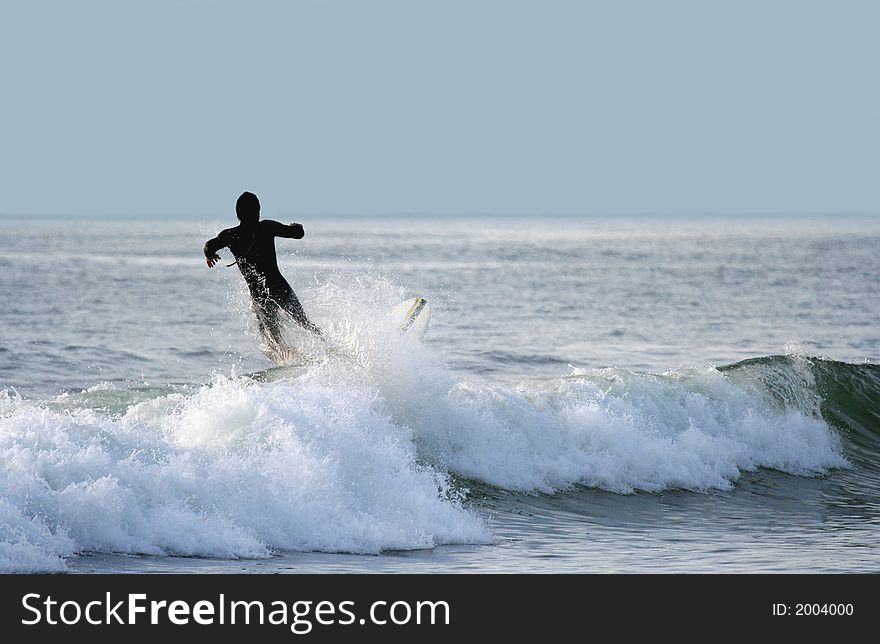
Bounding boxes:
[205,192,321,348]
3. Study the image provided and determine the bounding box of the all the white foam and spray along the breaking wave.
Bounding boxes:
[0,282,846,571]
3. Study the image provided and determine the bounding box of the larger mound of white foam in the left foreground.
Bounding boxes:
[0,378,492,570]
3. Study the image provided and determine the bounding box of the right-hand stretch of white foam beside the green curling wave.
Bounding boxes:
[420,369,846,493]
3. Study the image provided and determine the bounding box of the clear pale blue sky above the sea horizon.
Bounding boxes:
[0,0,880,214]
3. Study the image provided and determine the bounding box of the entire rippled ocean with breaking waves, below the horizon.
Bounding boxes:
[0,213,880,573]
